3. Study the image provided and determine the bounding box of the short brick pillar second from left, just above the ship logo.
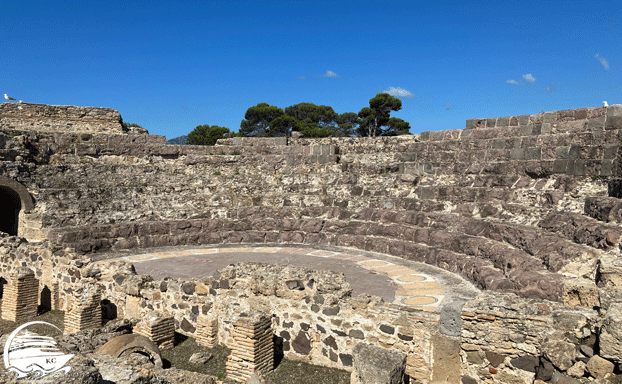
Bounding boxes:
[64,285,102,335]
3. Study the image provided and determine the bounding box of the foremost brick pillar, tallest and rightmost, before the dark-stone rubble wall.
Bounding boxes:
[226,313,274,383]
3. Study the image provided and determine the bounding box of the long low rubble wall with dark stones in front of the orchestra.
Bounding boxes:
[0,237,622,384]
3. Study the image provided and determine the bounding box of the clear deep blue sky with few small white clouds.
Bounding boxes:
[0,0,622,139]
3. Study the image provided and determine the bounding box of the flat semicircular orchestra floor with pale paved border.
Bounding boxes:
[111,247,454,312]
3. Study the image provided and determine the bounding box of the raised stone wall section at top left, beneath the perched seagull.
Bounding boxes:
[0,103,123,134]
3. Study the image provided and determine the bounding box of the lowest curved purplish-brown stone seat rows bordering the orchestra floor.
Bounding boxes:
[46,207,604,300]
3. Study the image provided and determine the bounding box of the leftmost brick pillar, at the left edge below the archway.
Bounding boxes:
[2,267,39,321]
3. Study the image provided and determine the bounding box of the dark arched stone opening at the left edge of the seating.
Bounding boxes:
[0,176,35,236]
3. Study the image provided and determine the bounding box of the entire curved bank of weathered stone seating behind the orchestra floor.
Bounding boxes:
[0,105,622,300]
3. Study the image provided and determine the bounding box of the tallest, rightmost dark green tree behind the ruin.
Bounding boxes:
[357,93,402,137]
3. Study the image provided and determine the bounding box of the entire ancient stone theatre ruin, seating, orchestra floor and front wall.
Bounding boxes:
[0,103,622,384]
